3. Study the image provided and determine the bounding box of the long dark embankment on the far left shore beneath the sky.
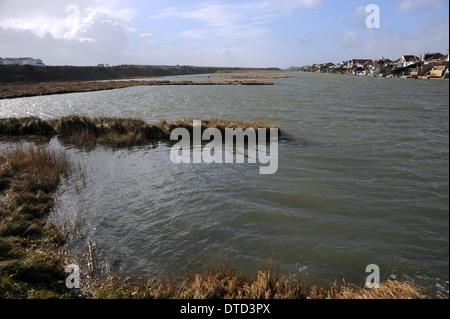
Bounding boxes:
[0,65,278,84]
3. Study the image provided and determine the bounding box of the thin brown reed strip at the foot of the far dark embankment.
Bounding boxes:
[0,79,273,99]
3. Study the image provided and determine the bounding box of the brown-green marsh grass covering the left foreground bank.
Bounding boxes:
[0,147,76,298]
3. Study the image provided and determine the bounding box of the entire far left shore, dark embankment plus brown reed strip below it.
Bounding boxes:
[0,65,278,99]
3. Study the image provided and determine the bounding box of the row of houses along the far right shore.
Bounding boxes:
[296,52,449,78]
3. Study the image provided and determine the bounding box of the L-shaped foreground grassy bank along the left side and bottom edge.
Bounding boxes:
[0,148,436,299]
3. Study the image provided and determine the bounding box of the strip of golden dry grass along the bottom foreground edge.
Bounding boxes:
[81,263,429,300]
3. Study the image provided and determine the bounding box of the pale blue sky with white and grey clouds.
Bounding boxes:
[0,0,449,68]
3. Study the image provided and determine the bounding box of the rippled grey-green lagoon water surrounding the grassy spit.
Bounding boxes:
[0,73,449,290]
